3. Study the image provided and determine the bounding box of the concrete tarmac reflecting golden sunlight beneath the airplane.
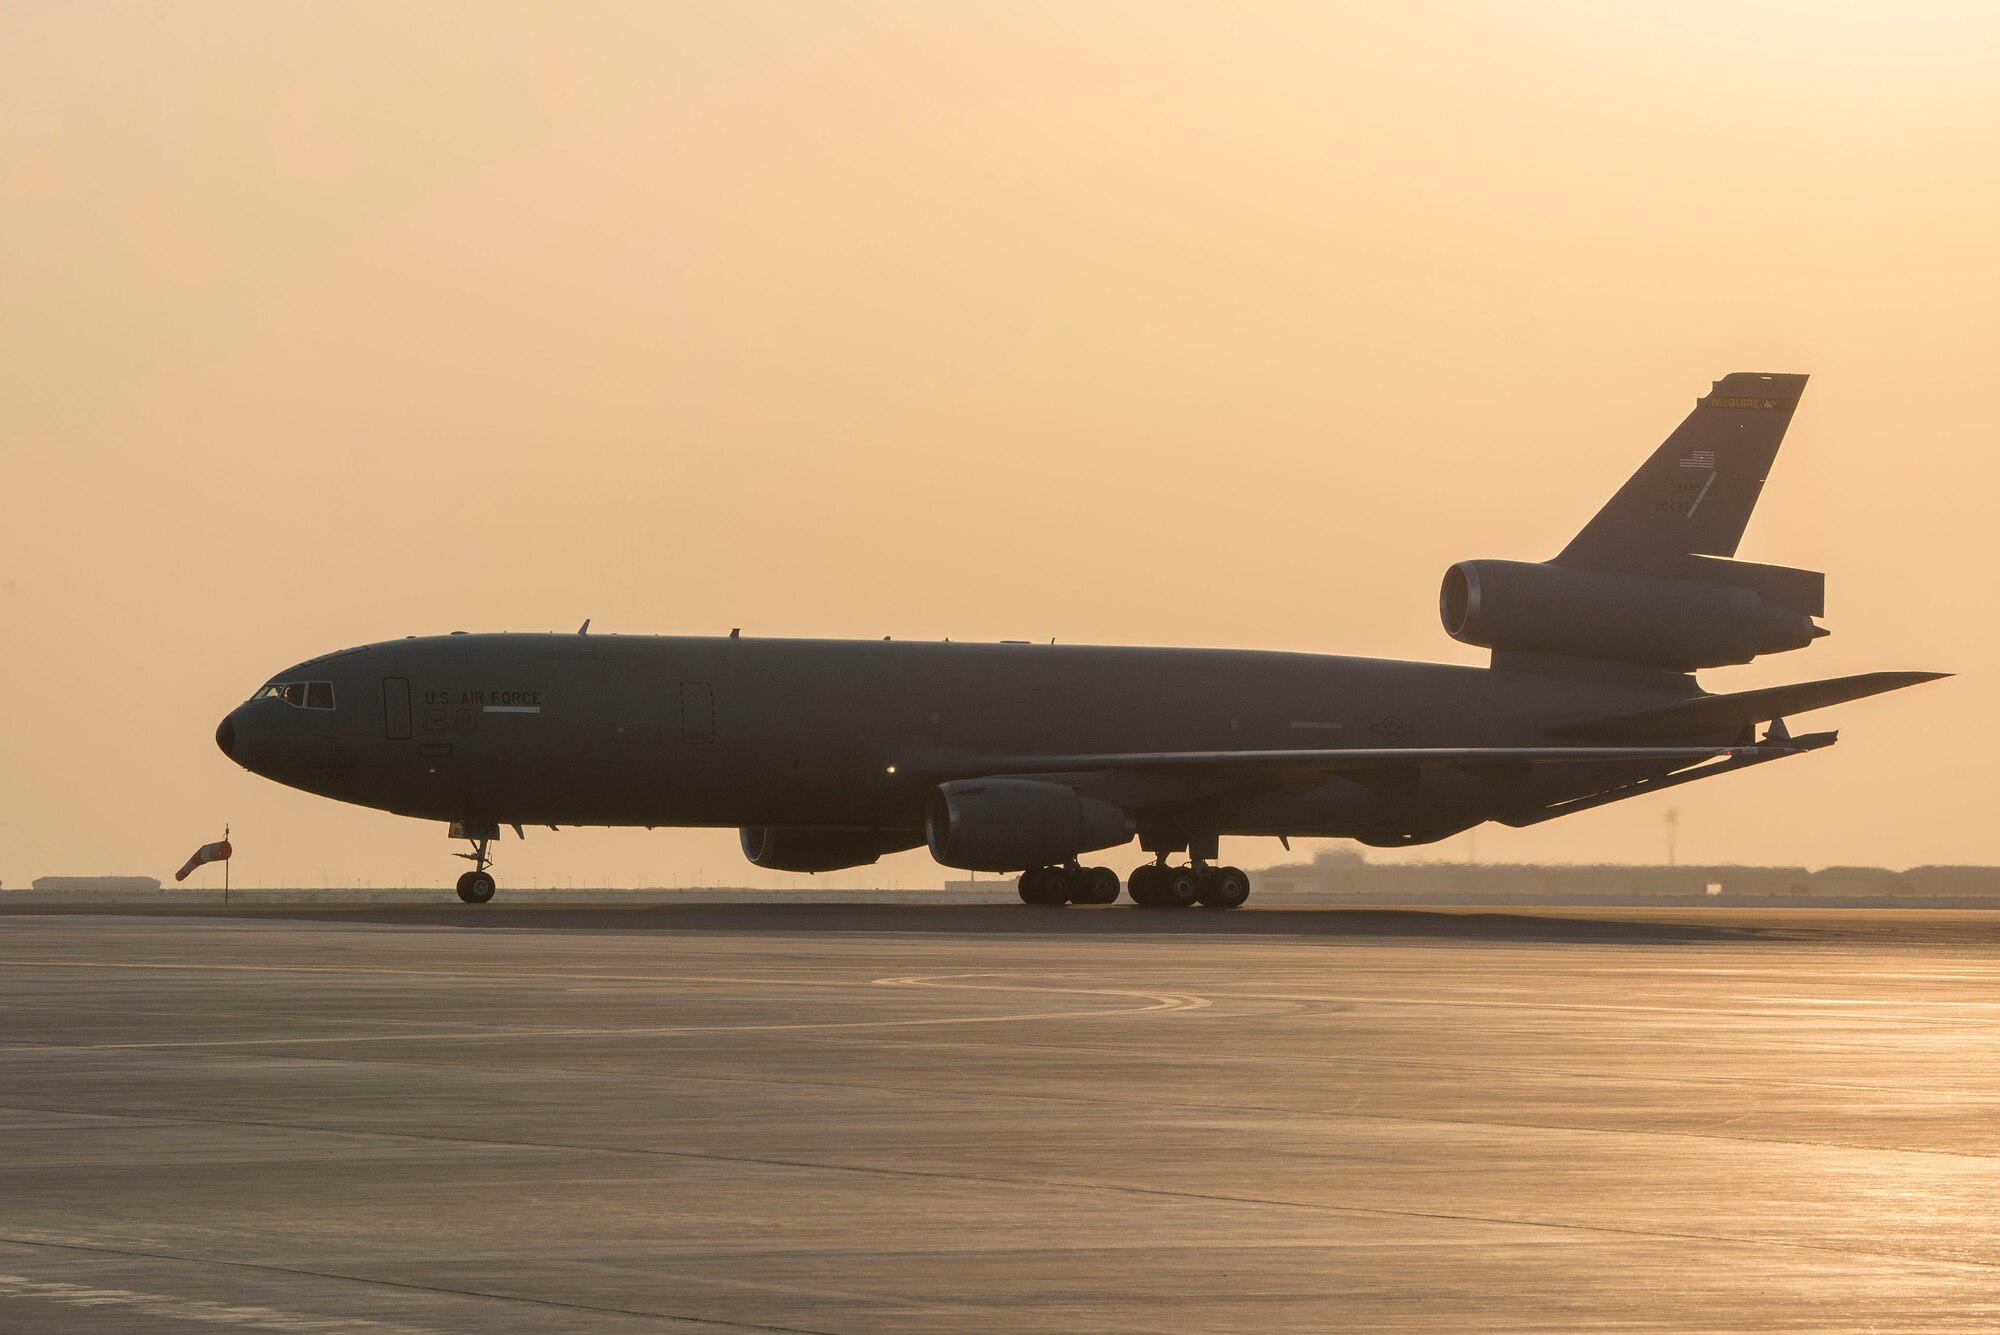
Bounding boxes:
[0,891,2000,1335]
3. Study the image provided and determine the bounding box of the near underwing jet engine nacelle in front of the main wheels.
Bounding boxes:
[928,779,1134,871]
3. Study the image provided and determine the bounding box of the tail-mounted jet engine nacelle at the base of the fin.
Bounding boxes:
[1438,562,1826,671]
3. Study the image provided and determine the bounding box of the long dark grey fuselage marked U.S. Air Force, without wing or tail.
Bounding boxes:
[215,634,1694,837]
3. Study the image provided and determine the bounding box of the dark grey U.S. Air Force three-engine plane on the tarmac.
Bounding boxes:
[216,372,1948,909]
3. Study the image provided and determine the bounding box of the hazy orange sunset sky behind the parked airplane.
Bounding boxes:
[0,0,2000,887]
